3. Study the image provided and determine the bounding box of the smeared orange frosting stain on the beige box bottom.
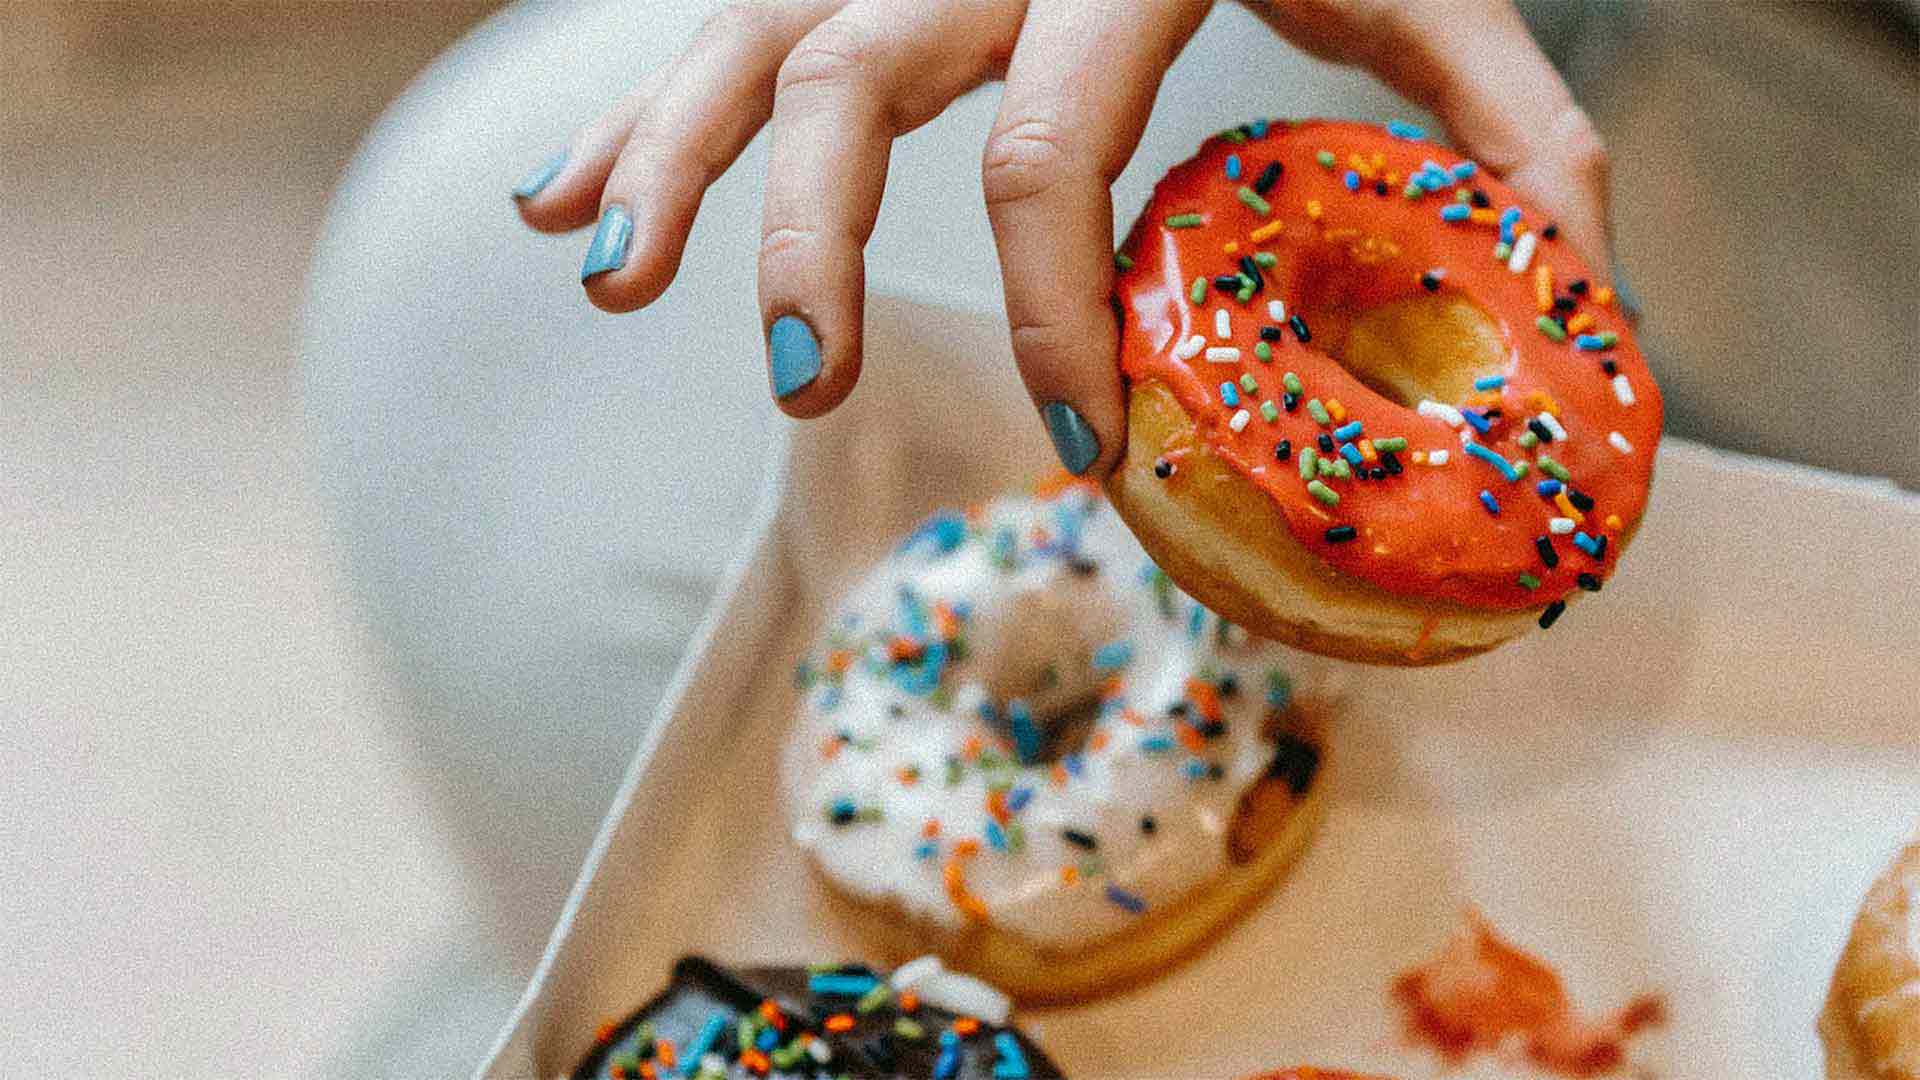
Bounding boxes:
[1392,911,1667,1076]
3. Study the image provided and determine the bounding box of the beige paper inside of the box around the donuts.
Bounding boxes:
[482,300,1920,1078]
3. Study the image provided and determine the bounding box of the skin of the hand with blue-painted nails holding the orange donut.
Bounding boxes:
[518,0,1607,477]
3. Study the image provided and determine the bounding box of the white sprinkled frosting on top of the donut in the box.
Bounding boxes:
[785,488,1320,947]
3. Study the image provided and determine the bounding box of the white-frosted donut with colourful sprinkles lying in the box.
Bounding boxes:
[785,484,1321,999]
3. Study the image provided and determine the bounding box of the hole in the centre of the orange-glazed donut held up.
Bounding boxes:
[1294,258,1511,407]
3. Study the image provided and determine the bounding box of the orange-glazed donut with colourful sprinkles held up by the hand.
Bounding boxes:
[1108,113,1661,665]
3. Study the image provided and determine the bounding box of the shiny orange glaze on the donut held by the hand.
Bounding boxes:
[1114,121,1661,609]
